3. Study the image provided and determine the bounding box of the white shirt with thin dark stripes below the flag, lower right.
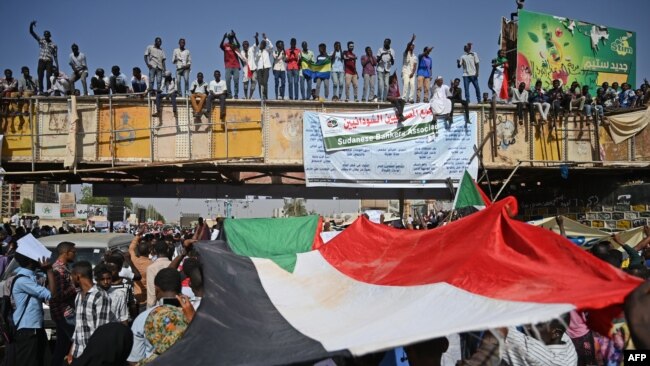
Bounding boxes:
[502,327,578,366]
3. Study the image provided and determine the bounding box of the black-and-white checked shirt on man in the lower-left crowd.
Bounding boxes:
[72,285,115,358]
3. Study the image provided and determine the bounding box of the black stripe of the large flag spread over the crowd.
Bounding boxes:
[152,241,350,366]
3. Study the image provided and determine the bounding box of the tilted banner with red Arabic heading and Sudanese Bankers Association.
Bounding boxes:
[318,103,435,152]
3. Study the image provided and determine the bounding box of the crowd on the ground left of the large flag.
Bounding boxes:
[1,218,215,365]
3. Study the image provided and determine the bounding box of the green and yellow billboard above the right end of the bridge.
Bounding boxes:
[516,10,636,92]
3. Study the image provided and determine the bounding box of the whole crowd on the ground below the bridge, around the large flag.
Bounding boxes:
[2,206,650,366]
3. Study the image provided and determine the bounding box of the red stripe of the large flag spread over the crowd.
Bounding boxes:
[319,197,641,309]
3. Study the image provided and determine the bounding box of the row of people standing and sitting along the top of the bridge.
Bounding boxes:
[0,21,650,129]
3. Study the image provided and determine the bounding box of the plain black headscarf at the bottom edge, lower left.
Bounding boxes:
[72,322,133,366]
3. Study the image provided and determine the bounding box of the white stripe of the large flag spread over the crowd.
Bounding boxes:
[252,251,575,355]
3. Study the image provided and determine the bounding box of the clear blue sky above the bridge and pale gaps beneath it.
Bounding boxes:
[5,0,650,217]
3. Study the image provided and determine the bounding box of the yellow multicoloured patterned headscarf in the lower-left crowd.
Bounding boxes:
[138,305,188,366]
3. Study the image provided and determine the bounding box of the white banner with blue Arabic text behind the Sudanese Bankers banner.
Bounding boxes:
[303,111,478,188]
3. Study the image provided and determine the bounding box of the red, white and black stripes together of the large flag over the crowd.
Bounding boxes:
[153,198,641,365]
